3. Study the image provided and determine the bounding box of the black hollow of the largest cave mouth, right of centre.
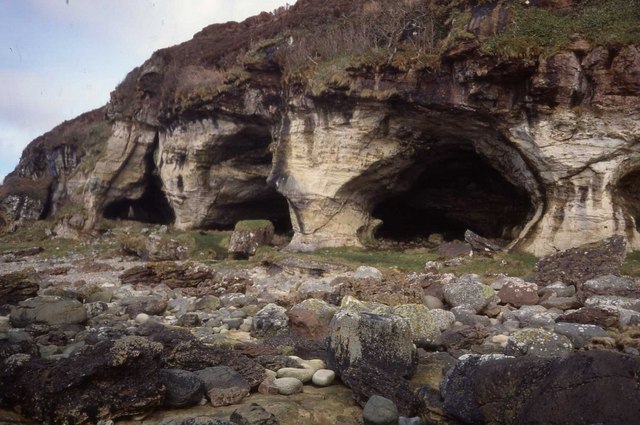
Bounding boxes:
[372,148,534,242]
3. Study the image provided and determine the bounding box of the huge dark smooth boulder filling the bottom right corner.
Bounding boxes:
[441,350,640,425]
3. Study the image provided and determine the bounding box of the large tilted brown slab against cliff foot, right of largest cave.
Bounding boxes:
[535,236,627,286]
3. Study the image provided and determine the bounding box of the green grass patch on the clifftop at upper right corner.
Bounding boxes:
[483,0,640,57]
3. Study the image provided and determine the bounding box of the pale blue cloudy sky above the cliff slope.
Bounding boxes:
[0,0,295,181]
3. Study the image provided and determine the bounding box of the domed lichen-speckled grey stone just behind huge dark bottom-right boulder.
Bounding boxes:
[505,329,573,357]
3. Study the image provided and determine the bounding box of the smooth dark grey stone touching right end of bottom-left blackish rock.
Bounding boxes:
[159,369,205,407]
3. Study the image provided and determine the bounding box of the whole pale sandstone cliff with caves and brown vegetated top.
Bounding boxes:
[0,0,640,255]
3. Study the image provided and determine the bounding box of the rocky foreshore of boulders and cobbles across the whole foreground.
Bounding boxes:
[0,234,640,425]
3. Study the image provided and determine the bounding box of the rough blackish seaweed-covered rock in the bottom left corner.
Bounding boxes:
[0,337,165,424]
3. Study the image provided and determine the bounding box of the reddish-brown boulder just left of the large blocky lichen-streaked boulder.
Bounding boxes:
[287,298,338,339]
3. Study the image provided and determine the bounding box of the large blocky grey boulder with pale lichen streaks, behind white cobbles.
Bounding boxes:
[328,310,417,377]
